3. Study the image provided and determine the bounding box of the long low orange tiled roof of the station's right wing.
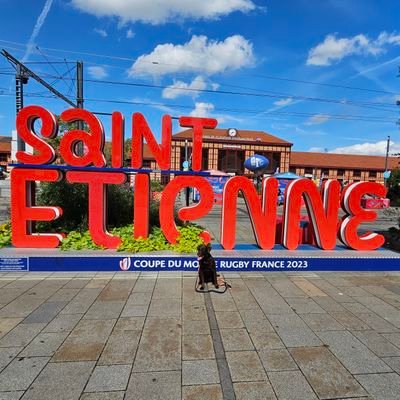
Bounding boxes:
[290,151,400,171]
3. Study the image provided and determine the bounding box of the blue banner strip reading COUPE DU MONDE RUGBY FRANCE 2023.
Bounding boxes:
[23,252,400,272]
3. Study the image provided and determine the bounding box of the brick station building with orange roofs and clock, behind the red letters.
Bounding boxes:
[143,128,399,183]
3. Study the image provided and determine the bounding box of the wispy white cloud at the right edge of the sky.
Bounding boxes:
[307,31,400,66]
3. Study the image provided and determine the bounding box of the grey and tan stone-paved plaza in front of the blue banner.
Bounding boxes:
[0,272,400,400]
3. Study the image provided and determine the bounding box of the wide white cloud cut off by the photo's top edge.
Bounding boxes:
[72,0,256,25]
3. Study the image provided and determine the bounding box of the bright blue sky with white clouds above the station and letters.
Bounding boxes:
[0,0,400,154]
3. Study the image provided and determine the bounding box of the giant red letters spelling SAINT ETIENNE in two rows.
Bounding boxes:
[11,106,386,250]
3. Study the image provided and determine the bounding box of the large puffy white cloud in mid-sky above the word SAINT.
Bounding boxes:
[128,35,255,77]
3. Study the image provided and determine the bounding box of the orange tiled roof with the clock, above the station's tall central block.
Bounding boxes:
[172,129,293,146]
